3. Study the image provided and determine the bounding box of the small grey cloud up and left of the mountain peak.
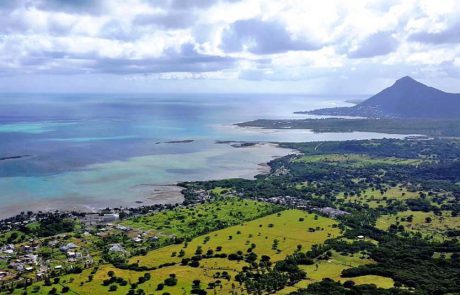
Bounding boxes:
[348,32,398,58]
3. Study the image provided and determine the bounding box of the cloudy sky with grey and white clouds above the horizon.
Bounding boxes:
[0,0,460,94]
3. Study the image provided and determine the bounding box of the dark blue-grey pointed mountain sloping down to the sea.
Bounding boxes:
[306,76,460,119]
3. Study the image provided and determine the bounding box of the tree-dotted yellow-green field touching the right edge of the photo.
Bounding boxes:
[376,211,460,239]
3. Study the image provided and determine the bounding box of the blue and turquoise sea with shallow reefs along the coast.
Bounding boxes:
[0,94,410,216]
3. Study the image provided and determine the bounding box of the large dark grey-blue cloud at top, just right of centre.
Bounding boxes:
[221,19,320,54]
